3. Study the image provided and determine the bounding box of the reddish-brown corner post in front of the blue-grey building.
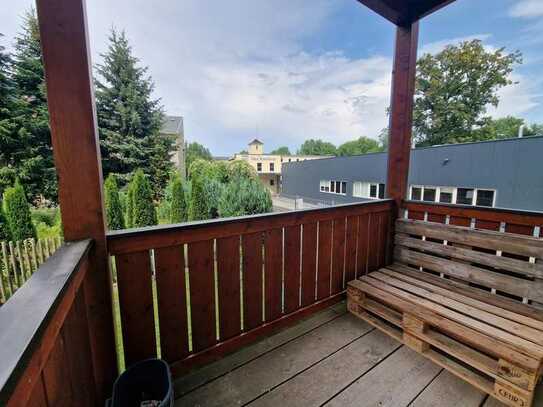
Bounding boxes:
[386,22,419,208]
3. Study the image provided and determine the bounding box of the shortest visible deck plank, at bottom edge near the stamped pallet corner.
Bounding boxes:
[410,370,486,407]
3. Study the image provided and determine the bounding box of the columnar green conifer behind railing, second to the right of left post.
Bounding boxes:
[129,170,158,228]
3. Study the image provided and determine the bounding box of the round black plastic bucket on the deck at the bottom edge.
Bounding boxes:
[106,359,173,407]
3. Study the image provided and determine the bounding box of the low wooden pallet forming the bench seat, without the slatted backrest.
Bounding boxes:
[347,266,543,407]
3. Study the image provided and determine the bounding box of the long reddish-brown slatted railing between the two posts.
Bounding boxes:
[108,200,393,374]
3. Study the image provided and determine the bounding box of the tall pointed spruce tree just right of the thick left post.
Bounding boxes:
[95,29,175,196]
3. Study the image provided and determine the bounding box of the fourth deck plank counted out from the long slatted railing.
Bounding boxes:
[325,346,441,407]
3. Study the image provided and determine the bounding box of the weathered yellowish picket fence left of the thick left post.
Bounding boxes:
[0,237,62,305]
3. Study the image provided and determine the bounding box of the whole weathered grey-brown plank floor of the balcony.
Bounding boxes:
[175,303,543,407]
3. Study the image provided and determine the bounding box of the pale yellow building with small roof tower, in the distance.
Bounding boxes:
[232,139,329,195]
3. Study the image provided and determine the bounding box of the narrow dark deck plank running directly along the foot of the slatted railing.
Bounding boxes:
[174,302,347,398]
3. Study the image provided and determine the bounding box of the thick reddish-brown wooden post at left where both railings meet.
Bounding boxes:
[37,0,117,401]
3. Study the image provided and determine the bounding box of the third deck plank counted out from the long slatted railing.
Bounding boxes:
[250,329,401,407]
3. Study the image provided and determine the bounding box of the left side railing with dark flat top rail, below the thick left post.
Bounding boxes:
[0,240,95,406]
